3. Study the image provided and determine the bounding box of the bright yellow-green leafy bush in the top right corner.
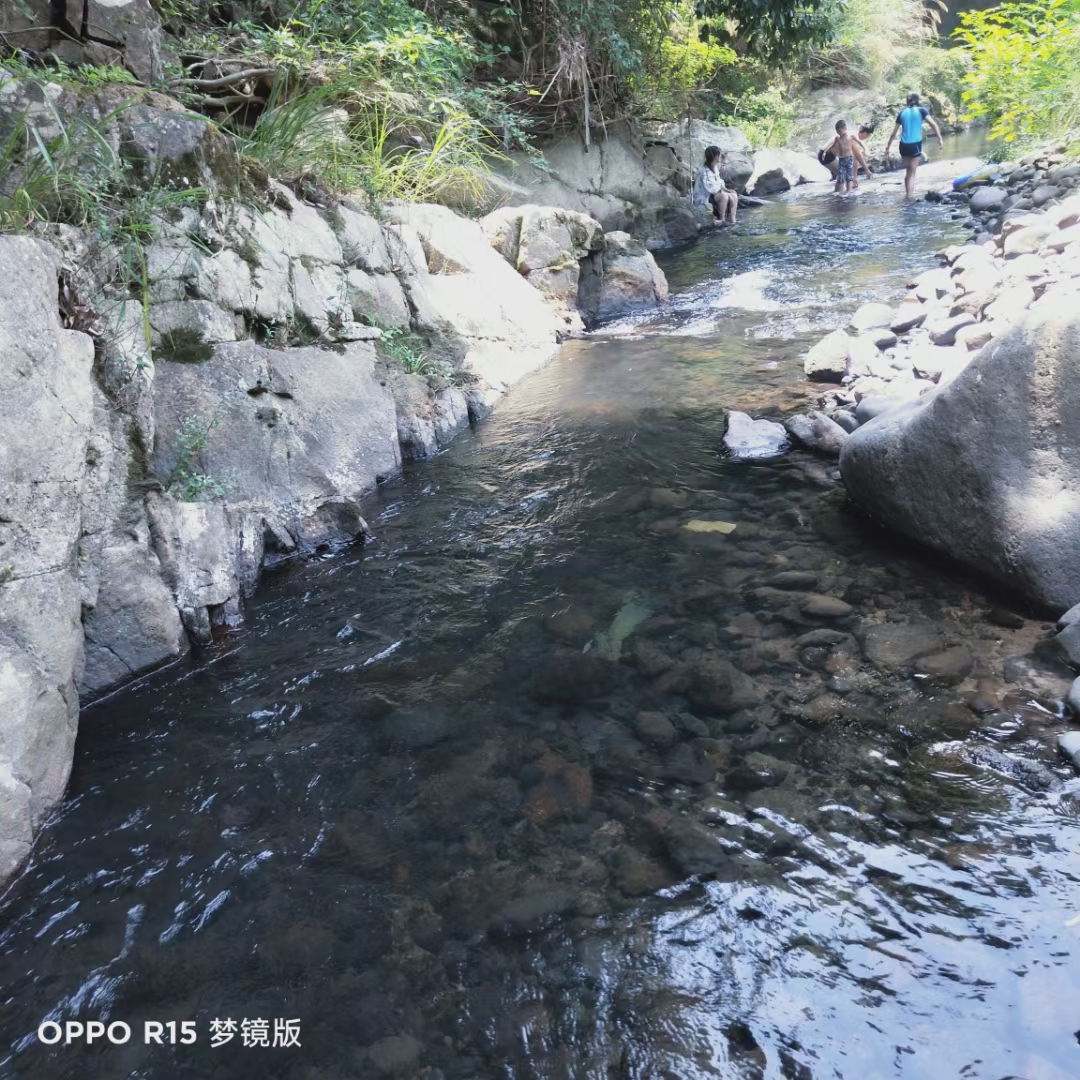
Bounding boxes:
[956,0,1080,145]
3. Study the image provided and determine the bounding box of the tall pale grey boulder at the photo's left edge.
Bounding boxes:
[0,237,94,878]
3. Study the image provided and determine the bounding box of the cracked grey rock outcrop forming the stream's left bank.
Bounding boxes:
[0,184,557,878]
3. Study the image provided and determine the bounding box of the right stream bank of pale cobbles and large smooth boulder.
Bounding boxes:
[760,145,1080,767]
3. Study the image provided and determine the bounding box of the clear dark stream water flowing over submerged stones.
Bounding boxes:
[0,141,1080,1080]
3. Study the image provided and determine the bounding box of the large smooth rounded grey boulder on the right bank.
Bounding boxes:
[840,292,1080,610]
